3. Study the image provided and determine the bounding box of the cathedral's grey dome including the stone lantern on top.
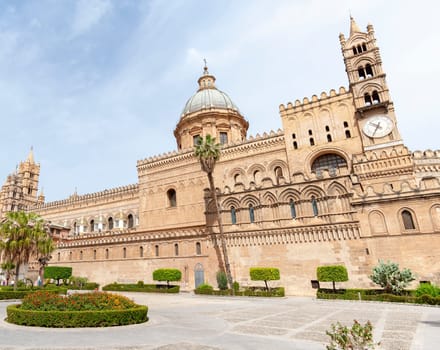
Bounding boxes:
[182,66,239,117]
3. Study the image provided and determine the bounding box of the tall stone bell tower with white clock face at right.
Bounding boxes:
[339,17,402,151]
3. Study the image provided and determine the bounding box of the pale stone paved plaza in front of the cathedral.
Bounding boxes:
[0,293,440,350]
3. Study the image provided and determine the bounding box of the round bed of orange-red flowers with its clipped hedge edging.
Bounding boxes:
[7,291,148,328]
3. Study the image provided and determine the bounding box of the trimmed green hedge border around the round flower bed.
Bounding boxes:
[7,304,148,328]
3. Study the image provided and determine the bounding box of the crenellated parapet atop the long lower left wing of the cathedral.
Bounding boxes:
[33,184,139,211]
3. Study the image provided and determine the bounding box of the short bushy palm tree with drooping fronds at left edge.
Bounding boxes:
[0,211,53,289]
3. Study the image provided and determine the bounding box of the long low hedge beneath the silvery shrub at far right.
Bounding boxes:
[316,289,440,305]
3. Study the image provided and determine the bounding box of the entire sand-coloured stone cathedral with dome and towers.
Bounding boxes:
[0,18,440,295]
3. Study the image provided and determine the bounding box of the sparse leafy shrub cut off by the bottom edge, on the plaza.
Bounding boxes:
[325,320,377,350]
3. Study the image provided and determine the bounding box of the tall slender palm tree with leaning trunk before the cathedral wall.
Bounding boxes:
[194,134,234,291]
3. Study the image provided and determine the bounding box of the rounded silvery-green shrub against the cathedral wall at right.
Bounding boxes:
[370,260,415,294]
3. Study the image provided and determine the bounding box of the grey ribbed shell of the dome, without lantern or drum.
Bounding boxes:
[182,88,238,115]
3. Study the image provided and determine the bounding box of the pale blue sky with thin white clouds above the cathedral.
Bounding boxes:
[0,0,440,201]
